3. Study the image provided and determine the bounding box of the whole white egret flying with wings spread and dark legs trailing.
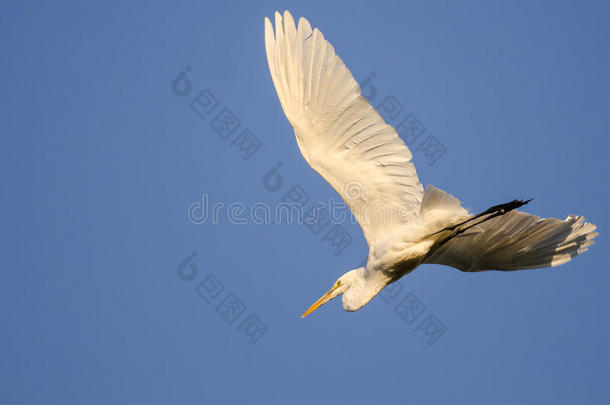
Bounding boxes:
[265,11,597,317]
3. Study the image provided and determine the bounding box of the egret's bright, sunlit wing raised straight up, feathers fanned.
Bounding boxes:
[265,11,422,245]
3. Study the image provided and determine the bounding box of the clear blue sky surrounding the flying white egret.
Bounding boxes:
[0,1,610,404]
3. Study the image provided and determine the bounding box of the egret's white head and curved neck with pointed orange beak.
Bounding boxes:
[301,267,366,318]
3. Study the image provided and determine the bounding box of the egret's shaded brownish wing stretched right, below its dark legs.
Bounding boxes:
[424,211,597,271]
